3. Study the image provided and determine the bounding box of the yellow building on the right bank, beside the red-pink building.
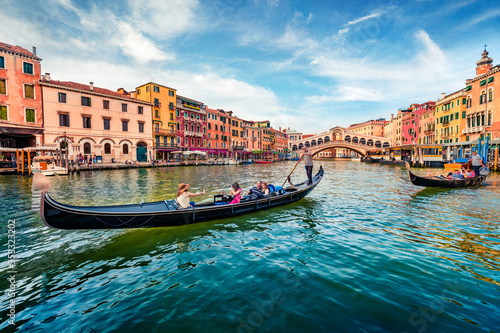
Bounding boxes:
[435,88,467,144]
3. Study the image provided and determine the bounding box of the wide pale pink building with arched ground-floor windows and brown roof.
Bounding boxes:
[40,75,153,163]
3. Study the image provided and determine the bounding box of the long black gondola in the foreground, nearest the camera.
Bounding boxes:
[33,167,324,229]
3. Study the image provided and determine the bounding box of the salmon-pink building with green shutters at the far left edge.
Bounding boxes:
[0,43,43,148]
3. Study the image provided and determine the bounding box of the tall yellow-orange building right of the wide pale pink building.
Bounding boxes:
[135,82,179,154]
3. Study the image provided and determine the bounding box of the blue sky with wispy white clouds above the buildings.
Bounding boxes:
[0,0,500,134]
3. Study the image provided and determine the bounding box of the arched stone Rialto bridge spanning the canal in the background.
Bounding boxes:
[290,127,391,157]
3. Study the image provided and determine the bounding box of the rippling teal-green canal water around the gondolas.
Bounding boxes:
[0,161,500,333]
